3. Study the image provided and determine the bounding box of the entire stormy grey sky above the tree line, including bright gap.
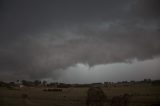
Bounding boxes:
[0,0,160,83]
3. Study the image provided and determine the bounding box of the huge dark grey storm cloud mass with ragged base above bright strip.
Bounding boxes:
[0,0,160,80]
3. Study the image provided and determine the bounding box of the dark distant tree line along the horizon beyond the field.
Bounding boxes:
[0,79,160,88]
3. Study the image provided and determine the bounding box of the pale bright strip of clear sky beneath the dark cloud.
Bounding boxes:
[42,57,160,83]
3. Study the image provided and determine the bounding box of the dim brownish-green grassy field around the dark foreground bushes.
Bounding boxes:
[0,85,160,106]
